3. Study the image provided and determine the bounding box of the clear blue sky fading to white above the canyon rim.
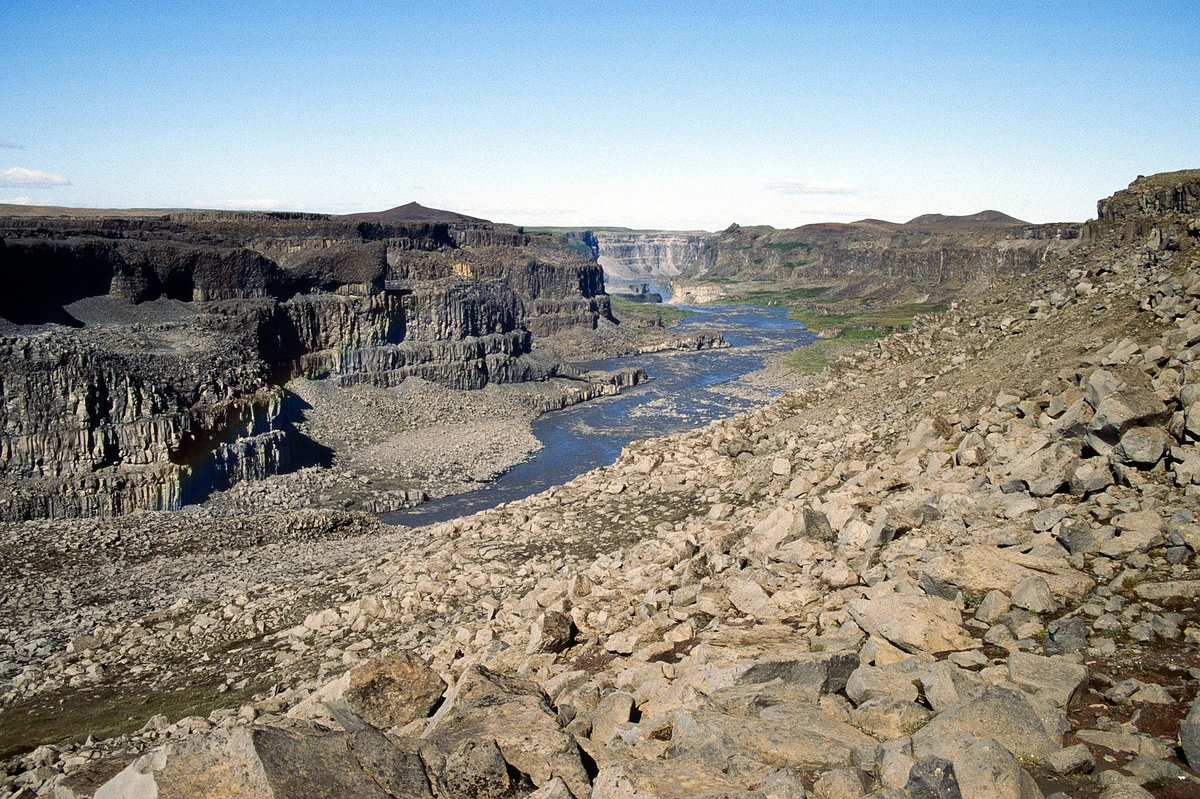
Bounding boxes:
[0,0,1200,230]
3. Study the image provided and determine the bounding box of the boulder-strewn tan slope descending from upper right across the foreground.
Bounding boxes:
[5,175,1200,799]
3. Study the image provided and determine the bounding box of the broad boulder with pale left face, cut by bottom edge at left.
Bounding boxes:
[95,727,433,799]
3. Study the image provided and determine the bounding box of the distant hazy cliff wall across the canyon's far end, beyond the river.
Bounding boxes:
[578,214,1089,302]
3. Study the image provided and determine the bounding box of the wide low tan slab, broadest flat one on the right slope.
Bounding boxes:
[925,543,1096,603]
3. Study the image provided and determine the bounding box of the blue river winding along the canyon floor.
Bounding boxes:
[380,305,814,527]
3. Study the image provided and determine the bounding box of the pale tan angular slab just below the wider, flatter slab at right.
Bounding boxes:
[846,594,980,653]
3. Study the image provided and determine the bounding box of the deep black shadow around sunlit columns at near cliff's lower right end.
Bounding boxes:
[172,390,334,505]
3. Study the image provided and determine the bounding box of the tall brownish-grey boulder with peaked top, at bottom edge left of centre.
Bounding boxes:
[422,666,590,797]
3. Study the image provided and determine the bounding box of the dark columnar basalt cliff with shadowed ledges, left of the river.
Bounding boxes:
[0,209,610,519]
